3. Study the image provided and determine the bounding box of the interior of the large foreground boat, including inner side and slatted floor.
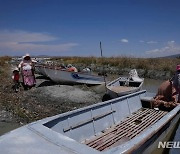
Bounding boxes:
[44,91,168,151]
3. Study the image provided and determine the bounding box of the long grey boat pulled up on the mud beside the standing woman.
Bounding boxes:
[35,65,104,85]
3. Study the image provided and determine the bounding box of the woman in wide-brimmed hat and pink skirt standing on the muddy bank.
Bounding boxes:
[18,54,36,89]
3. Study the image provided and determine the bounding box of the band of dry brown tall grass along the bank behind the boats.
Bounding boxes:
[53,57,180,72]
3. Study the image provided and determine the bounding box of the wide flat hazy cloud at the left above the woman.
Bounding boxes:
[0,30,78,52]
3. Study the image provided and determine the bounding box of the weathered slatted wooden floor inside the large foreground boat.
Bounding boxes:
[84,108,167,151]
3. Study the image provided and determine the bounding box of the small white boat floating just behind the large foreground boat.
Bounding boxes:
[106,69,144,98]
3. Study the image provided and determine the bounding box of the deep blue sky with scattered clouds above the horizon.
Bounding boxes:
[0,0,180,57]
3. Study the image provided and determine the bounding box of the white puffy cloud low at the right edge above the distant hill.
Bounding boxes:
[145,41,180,57]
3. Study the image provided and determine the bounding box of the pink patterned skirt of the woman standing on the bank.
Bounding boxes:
[22,70,36,86]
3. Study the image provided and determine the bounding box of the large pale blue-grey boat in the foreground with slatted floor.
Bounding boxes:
[0,91,180,154]
